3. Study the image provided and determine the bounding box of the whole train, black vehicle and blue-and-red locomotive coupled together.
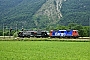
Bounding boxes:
[18,30,79,38]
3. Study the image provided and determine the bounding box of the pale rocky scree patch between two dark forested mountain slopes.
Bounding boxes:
[33,0,62,27]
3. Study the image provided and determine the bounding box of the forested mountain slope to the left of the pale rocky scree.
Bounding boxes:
[0,0,46,28]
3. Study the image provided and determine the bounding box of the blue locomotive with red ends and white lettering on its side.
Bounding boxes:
[49,30,79,38]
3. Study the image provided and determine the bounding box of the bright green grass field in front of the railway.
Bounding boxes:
[0,41,90,60]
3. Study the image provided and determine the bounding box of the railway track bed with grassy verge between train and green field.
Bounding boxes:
[0,36,90,41]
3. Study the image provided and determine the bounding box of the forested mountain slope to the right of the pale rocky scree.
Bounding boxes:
[60,0,90,26]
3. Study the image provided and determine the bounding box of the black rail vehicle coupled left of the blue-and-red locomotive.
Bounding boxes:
[18,30,49,38]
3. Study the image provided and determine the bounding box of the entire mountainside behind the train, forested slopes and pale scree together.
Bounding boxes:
[0,0,90,29]
